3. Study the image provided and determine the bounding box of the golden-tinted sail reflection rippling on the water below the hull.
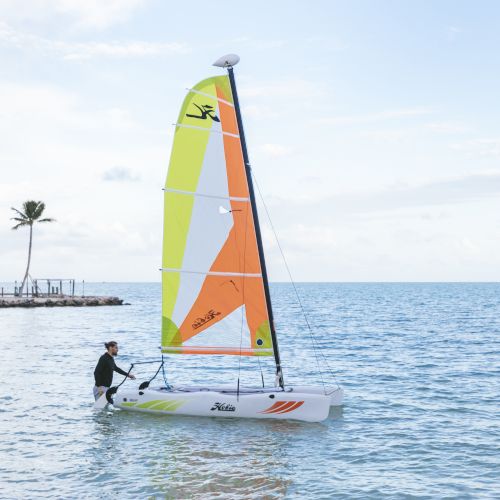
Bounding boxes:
[150,422,288,498]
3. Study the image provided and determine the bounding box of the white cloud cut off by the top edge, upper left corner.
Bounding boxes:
[0,0,146,29]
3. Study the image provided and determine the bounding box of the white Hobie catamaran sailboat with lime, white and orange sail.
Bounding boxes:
[97,54,343,422]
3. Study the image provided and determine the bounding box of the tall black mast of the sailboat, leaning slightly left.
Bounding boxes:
[227,65,285,388]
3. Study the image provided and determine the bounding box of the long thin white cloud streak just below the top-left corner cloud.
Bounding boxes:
[0,22,189,60]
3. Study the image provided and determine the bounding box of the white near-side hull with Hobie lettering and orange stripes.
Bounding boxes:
[113,388,331,422]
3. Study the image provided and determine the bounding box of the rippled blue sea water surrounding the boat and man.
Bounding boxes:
[0,283,500,499]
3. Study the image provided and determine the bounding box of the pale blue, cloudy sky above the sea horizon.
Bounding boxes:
[0,0,500,281]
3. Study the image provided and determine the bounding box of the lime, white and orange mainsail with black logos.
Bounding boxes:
[162,76,273,356]
